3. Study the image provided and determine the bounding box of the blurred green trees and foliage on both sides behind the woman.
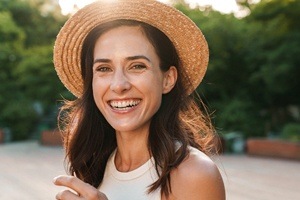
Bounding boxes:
[0,0,300,142]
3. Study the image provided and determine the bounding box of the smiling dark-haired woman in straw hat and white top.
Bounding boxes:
[54,0,225,200]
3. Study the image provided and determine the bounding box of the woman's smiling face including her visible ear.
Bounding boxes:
[92,26,177,132]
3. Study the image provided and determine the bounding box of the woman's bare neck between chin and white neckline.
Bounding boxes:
[115,131,151,172]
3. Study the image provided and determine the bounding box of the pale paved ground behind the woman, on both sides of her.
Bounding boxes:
[0,141,300,200]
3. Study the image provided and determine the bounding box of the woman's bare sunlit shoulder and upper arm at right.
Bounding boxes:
[170,148,225,200]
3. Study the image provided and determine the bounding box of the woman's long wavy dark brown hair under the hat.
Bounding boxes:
[59,20,215,196]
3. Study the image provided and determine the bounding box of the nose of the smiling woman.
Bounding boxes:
[110,69,131,94]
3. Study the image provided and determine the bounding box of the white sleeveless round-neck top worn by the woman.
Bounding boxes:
[99,150,161,200]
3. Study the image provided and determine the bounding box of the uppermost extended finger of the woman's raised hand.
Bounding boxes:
[53,175,94,196]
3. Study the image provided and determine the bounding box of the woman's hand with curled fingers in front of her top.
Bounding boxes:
[53,176,108,200]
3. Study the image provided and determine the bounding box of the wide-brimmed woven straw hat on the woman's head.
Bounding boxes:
[54,0,208,97]
